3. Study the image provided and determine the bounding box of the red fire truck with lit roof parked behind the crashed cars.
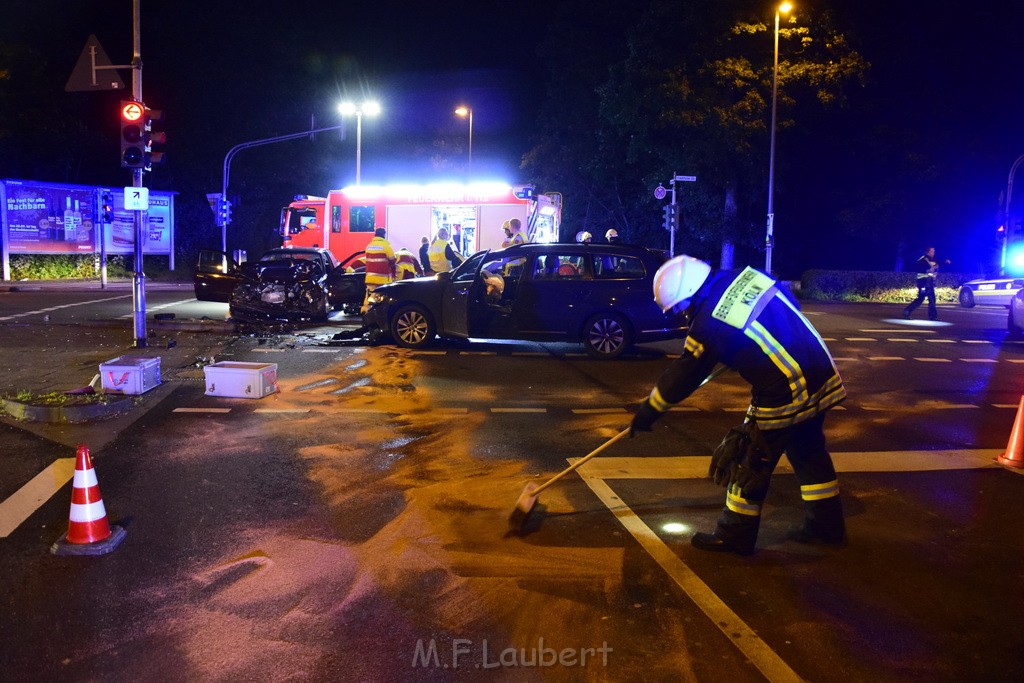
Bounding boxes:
[281,183,561,259]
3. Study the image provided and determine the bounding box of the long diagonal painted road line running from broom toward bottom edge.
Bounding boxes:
[584,476,802,682]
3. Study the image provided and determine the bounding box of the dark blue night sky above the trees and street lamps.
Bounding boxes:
[6,0,1024,267]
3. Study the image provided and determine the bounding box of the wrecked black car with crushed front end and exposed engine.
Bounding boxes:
[195,248,366,322]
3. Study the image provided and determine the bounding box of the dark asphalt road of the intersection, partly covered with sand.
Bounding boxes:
[0,292,1024,681]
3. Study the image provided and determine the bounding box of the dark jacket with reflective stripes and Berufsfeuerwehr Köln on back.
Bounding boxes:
[649,267,846,429]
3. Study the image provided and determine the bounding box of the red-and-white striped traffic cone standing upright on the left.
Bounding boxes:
[50,443,125,555]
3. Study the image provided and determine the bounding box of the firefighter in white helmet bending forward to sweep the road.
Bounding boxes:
[630,256,846,555]
